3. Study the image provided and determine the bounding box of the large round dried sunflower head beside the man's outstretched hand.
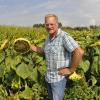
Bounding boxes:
[13,38,30,54]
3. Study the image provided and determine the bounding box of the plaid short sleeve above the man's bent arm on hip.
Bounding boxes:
[63,34,79,52]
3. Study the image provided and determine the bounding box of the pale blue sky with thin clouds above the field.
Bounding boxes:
[0,0,100,27]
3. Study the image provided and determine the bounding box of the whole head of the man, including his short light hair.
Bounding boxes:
[45,14,58,36]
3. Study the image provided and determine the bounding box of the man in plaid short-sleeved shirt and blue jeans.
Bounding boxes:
[31,14,84,100]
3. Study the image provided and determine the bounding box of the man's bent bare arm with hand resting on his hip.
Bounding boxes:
[58,47,84,75]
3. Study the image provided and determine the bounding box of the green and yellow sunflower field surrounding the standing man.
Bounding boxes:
[0,26,100,100]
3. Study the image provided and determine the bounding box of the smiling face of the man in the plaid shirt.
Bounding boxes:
[45,17,58,35]
